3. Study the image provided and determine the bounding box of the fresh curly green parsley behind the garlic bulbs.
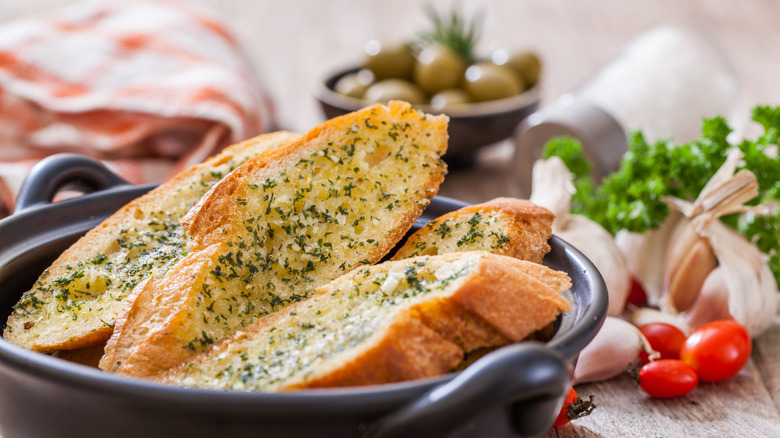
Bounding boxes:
[544,106,780,281]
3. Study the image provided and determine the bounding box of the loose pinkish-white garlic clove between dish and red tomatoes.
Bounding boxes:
[574,316,657,384]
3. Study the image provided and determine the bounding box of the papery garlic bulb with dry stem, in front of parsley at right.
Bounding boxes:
[660,149,777,336]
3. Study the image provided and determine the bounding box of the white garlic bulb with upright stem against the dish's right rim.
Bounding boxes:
[530,157,631,316]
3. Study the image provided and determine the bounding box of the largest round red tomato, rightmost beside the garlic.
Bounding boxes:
[680,320,753,382]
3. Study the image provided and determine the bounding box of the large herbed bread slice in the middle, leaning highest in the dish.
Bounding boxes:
[100,102,447,376]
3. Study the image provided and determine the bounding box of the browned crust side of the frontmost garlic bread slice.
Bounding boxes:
[290,254,571,390]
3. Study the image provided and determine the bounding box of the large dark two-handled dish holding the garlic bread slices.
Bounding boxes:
[0,155,607,438]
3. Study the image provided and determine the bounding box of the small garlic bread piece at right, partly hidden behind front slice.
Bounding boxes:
[392,198,555,263]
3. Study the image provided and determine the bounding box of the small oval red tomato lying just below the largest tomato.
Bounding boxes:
[639,359,699,398]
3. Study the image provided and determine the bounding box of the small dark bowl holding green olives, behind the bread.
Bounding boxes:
[317,68,539,166]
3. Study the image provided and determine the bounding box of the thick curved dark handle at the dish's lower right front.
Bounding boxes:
[367,342,571,438]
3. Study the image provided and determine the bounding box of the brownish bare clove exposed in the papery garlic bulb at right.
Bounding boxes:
[667,236,718,312]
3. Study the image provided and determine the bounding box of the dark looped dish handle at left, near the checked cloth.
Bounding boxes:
[14,153,130,213]
